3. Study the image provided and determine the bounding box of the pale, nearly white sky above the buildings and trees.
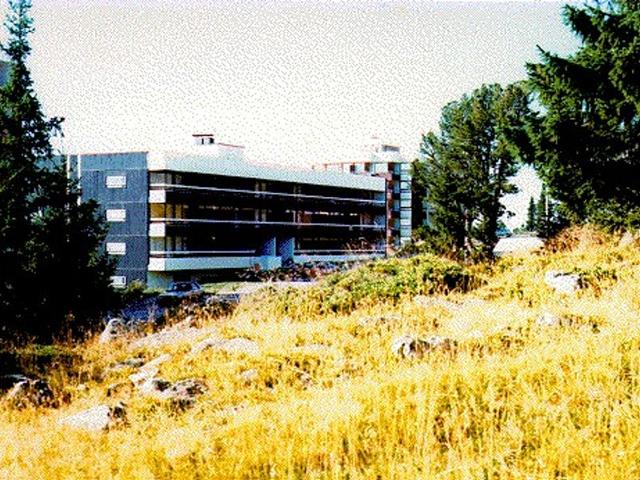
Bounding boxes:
[0,0,577,229]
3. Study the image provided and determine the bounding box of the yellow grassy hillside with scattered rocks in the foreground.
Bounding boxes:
[0,231,640,479]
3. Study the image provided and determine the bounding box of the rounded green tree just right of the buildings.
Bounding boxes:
[414,84,530,257]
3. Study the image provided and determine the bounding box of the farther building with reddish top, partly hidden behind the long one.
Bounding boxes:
[314,137,411,248]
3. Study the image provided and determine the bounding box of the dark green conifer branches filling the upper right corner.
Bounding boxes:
[527,0,640,227]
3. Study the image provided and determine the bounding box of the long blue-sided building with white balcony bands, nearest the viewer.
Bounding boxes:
[68,135,387,286]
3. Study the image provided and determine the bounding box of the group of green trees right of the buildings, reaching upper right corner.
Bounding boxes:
[413,0,640,257]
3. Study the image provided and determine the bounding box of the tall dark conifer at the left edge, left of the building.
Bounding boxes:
[0,0,113,344]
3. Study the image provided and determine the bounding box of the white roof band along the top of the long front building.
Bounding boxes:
[147,149,386,192]
